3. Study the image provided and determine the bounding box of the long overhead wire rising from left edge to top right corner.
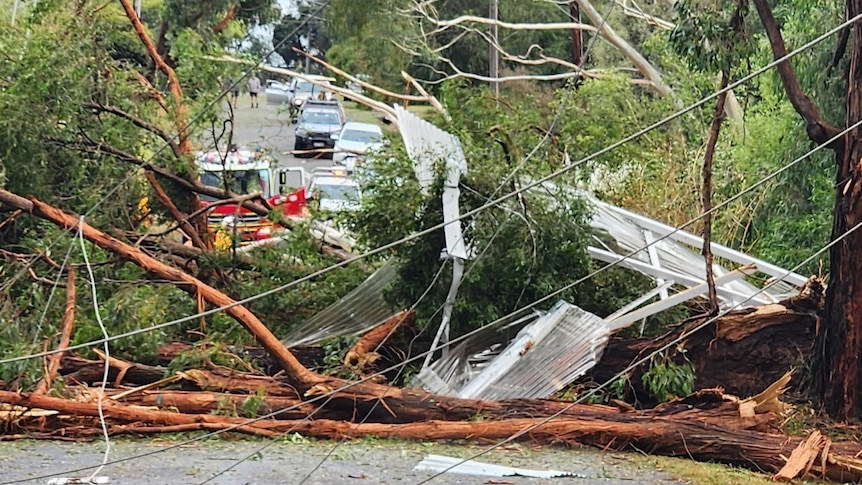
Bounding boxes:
[0,8,862,365]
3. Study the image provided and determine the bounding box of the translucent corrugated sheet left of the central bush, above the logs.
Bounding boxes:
[282,262,397,348]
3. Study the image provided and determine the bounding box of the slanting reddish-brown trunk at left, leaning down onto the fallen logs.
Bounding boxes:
[0,189,322,385]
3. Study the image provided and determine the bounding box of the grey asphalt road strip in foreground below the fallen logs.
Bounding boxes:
[0,435,683,485]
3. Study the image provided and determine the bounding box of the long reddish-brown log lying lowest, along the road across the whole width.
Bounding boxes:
[0,391,862,481]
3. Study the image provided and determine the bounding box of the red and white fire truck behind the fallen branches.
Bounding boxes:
[195,149,306,244]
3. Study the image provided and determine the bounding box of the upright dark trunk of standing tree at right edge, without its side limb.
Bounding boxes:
[815,0,862,420]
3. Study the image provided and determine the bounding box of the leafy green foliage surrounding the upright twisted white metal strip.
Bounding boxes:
[352,86,650,335]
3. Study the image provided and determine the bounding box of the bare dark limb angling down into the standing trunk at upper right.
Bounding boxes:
[753,0,844,144]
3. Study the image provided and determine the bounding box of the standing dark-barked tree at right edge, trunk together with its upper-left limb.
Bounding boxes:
[754,0,862,420]
